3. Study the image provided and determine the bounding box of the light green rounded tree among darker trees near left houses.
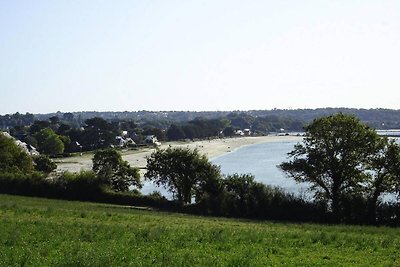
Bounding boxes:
[35,128,64,155]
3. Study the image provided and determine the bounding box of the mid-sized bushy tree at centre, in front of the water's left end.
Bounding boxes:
[144,148,219,205]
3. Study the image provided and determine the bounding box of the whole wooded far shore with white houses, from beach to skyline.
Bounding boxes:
[0,109,400,156]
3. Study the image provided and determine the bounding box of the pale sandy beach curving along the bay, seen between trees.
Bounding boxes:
[57,135,301,172]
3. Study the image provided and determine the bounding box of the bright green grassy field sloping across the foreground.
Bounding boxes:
[0,195,400,266]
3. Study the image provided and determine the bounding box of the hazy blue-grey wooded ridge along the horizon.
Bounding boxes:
[0,108,400,129]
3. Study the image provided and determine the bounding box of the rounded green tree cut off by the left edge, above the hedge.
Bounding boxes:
[0,133,33,174]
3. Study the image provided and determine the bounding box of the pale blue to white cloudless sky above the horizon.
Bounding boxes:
[0,0,400,114]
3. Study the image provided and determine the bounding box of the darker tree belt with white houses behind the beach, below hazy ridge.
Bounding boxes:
[3,113,303,156]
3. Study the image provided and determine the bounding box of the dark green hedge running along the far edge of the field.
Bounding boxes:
[0,171,400,226]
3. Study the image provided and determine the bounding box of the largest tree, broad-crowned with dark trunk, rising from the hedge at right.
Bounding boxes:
[280,113,379,221]
